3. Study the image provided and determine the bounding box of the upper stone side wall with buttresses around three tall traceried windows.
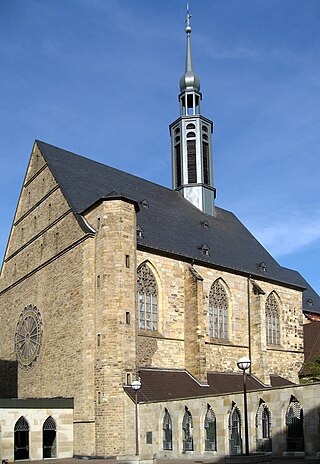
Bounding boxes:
[134,251,303,384]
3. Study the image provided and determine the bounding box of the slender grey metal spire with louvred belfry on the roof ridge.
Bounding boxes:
[169,5,215,215]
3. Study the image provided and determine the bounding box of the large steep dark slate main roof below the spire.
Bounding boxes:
[36,141,320,313]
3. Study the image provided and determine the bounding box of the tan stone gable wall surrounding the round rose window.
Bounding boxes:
[0,149,95,453]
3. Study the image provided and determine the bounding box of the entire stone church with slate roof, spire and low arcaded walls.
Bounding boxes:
[0,8,320,460]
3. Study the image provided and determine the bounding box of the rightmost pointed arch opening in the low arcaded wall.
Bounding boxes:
[286,396,304,451]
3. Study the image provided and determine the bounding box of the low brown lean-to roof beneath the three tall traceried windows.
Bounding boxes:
[124,368,294,403]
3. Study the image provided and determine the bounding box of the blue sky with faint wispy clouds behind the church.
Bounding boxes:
[0,0,320,292]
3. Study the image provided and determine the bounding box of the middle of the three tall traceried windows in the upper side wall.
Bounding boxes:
[209,280,228,339]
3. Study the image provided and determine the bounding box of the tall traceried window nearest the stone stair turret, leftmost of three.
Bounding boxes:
[137,264,158,330]
